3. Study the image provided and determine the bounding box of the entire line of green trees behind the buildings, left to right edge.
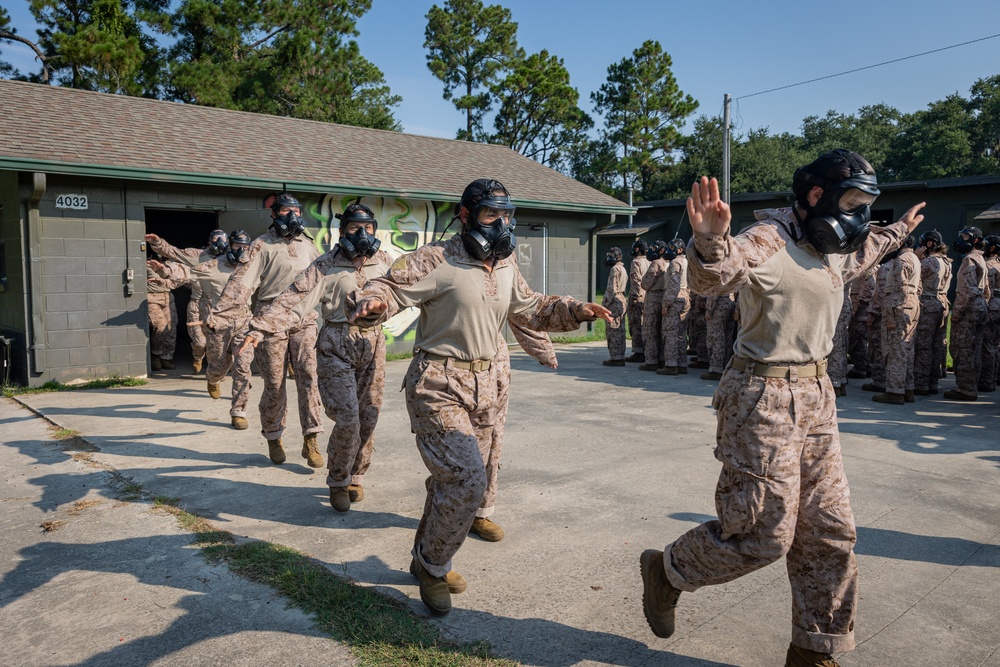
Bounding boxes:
[0,0,1000,201]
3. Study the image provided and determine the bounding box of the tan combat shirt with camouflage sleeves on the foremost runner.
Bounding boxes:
[687,208,907,364]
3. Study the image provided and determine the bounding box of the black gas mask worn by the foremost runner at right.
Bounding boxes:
[793,164,881,255]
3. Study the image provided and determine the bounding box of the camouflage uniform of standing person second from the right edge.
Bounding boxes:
[951,249,990,395]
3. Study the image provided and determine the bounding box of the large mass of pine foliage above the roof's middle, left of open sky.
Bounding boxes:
[168,0,401,130]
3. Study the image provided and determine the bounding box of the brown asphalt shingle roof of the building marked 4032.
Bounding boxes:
[0,80,629,213]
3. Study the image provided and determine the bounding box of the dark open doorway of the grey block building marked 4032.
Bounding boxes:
[146,208,219,373]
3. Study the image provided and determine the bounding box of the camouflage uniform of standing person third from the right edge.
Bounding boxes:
[913,253,951,393]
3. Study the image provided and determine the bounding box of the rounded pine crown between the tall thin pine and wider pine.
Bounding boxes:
[489,49,593,166]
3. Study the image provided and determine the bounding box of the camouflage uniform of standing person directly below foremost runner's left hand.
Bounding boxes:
[882,246,920,394]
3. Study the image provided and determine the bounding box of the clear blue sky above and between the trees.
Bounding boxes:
[0,0,1000,137]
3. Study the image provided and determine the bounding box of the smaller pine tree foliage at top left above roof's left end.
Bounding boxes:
[28,0,169,97]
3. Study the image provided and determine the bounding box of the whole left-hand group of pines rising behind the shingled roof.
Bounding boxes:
[0,0,401,130]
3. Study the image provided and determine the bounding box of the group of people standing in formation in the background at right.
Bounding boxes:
[603,227,1000,405]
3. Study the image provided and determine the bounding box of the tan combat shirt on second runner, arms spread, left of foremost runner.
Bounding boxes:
[348,234,584,361]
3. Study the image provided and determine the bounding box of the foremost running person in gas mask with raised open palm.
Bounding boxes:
[640,150,923,666]
